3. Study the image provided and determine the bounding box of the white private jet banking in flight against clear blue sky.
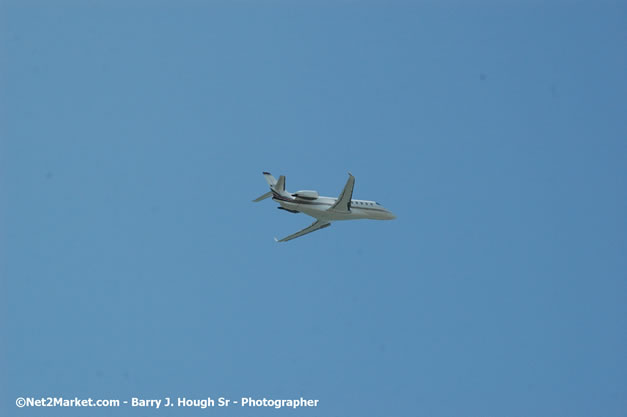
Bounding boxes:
[253,172,396,242]
